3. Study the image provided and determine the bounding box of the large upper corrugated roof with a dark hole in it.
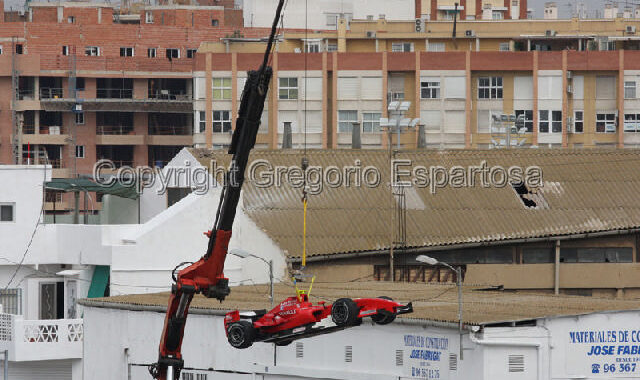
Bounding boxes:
[192,149,640,257]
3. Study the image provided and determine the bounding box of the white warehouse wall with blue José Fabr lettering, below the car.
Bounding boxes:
[84,307,640,380]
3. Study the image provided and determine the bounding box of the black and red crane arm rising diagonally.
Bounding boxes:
[149,0,285,380]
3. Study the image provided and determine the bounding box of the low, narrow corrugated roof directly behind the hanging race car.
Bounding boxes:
[81,281,640,325]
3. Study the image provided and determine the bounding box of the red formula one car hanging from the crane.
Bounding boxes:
[224,293,413,348]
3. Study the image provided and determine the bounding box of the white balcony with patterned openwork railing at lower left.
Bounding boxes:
[0,314,84,362]
